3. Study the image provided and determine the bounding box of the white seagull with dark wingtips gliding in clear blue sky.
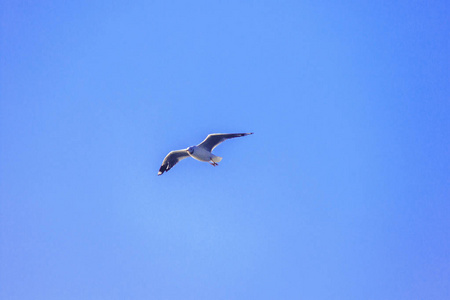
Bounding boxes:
[158,132,253,176]
